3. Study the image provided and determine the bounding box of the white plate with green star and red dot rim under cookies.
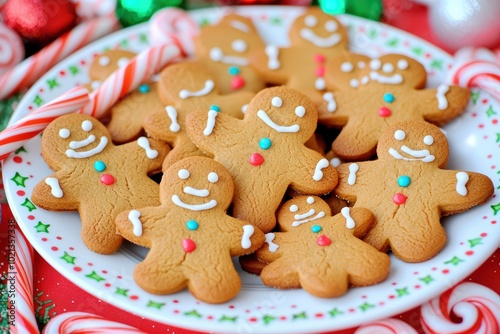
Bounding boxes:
[3,7,500,333]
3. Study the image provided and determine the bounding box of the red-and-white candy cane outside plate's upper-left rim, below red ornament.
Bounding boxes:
[0,16,118,100]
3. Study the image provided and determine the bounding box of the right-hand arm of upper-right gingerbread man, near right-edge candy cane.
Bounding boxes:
[415,85,470,125]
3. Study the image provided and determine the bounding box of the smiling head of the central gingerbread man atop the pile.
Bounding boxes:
[245,86,318,143]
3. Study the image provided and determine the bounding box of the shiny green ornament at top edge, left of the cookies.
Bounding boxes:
[115,0,184,27]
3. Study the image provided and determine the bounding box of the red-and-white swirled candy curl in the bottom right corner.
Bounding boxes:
[420,283,500,334]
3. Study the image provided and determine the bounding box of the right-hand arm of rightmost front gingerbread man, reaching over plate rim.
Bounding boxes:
[436,170,494,215]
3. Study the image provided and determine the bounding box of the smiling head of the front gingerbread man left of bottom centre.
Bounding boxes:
[160,158,234,211]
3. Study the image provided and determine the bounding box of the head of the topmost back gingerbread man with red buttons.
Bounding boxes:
[289,7,348,49]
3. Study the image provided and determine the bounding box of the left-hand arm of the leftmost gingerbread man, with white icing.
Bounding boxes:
[31,172,80,211]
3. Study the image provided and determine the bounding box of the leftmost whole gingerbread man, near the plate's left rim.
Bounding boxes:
[31,114,168,254]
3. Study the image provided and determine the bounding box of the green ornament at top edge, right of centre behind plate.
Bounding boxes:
[318,0,383,21]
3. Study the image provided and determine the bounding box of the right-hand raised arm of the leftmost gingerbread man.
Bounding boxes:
[117,137,170,174]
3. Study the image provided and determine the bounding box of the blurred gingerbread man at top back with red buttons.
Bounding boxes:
[250,7,348,103]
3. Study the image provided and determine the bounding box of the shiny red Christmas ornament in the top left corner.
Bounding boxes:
[2,0,77,46]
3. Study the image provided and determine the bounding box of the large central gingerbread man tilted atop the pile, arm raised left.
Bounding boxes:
[187,87,337,232]
